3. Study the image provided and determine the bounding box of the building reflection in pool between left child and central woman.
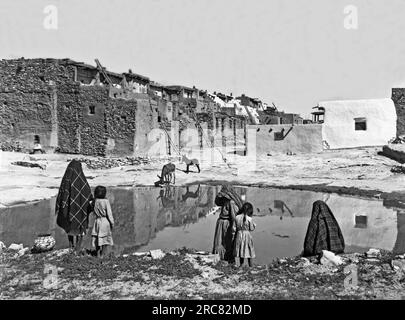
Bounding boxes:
[111,186,214,252]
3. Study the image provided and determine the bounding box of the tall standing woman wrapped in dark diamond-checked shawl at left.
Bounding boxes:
[55,160,93,251]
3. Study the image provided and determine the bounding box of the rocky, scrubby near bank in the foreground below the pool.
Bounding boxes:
[0,245,405,300]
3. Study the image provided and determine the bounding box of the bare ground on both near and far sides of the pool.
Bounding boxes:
[0,148,405,299]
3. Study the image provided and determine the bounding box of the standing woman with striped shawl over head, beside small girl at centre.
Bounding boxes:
[212,185,243,262]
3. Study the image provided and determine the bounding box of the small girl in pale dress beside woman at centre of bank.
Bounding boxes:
[233,202,256,267]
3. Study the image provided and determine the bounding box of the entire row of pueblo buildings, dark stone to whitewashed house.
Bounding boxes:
[0,58,405,156]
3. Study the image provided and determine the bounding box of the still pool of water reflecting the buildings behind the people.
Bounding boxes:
[0,185,405,264]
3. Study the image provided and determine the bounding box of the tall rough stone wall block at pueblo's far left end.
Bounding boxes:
[0,59,74,150]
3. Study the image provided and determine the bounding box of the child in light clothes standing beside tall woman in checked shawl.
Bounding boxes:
[91,186,114,257]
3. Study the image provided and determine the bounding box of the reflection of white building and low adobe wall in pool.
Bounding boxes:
[241,188,405,250]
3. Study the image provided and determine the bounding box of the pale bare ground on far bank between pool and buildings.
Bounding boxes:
[0,148,405,207]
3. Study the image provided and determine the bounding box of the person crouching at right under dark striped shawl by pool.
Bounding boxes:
[303,200,345,257]
